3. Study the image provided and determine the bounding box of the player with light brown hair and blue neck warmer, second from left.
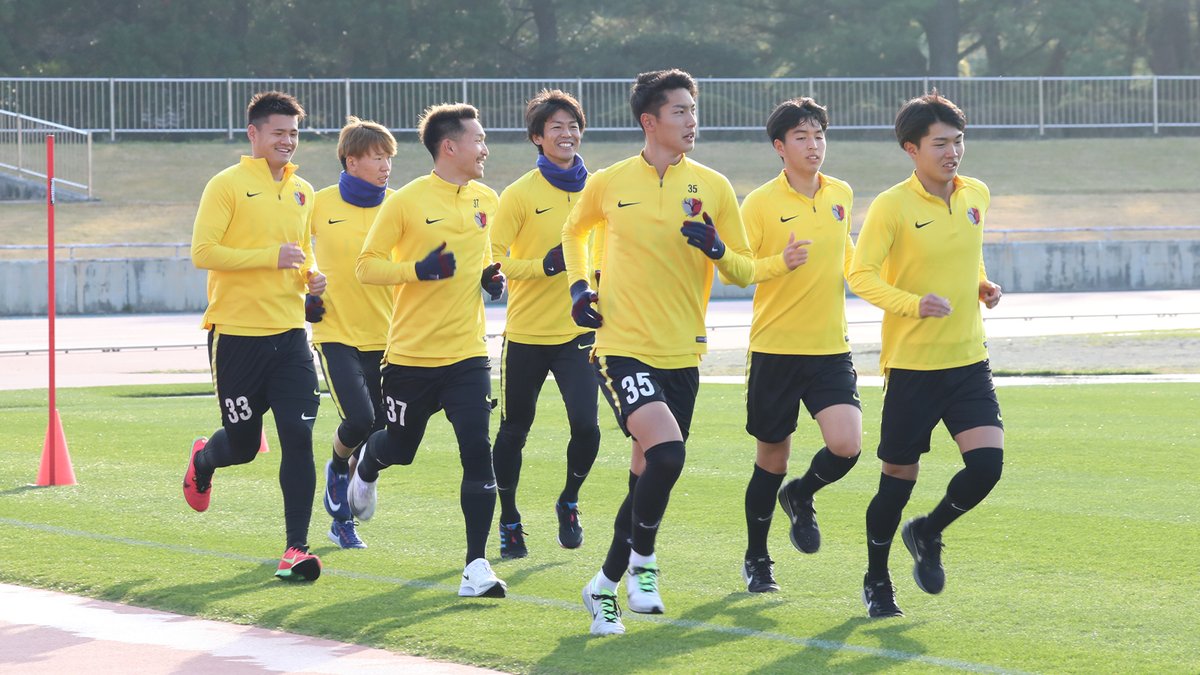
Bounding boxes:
[310,117,396,549]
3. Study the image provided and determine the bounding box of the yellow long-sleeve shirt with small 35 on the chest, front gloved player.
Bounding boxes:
[563,154,755,369]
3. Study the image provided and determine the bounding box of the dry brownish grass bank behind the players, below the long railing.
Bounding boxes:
[0,133,1200,252]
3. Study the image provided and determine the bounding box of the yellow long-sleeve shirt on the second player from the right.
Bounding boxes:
[742,172,854,356]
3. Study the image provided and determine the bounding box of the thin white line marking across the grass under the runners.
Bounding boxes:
[0,518,1024,675]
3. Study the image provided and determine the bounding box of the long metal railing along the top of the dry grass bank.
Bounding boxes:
[0,76,1200,139]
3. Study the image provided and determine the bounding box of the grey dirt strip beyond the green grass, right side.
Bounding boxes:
[700,330,1200,375]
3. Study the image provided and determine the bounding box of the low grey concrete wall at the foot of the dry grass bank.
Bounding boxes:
[0,240,1200,316]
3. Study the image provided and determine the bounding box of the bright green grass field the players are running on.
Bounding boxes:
[0,384,1200,673]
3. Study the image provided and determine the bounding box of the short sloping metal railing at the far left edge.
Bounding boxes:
[0,110,92,199]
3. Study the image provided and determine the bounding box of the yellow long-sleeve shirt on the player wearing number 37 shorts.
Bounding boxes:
[355,173,503,366]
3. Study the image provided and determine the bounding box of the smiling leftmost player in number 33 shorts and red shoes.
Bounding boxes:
[184,91,325,581]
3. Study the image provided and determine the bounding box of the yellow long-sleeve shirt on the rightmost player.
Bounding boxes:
[850,168,991,371]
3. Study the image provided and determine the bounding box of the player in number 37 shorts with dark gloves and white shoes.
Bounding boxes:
[348,103,506,597]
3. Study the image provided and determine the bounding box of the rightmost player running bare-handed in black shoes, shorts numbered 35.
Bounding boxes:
[850,90,1004,616]
